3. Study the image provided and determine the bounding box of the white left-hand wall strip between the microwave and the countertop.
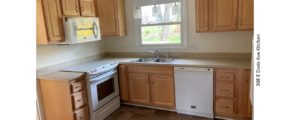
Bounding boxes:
[36,41,105,69]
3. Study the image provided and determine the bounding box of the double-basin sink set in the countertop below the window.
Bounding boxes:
[132,57,176,63]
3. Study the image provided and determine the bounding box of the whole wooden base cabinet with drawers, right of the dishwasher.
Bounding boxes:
[214,69,252,119]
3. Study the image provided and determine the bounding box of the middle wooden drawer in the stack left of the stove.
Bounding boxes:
[72,91,86,109]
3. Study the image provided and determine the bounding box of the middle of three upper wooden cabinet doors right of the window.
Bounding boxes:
[214,0,238,31]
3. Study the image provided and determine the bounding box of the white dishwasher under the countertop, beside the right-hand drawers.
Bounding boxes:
[174,67,214,118]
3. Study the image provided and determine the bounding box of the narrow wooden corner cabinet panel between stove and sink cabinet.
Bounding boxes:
[118,65,129,101]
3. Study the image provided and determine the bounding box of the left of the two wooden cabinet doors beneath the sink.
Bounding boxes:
[129,73,150,104]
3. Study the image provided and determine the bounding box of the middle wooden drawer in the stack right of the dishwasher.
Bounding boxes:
[215,83,234,97]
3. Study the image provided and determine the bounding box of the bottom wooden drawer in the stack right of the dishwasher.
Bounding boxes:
[215,99,234,114]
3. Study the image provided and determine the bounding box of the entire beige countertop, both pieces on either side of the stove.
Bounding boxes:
[37,57,251,80]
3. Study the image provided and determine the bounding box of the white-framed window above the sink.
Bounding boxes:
[135,0,186,47]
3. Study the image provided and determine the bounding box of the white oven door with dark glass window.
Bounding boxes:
[90,70,119,112]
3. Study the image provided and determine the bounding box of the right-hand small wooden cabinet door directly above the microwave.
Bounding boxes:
[80,0,96,16]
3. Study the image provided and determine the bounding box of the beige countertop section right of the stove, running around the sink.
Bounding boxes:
[98,57,251,69]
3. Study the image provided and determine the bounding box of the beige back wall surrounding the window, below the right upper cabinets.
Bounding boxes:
[105,0,253,53]
